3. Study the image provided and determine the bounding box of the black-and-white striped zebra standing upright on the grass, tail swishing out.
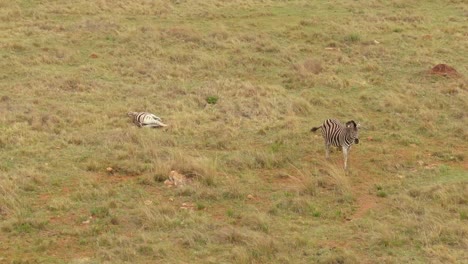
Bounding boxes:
[310,119,360,170]
